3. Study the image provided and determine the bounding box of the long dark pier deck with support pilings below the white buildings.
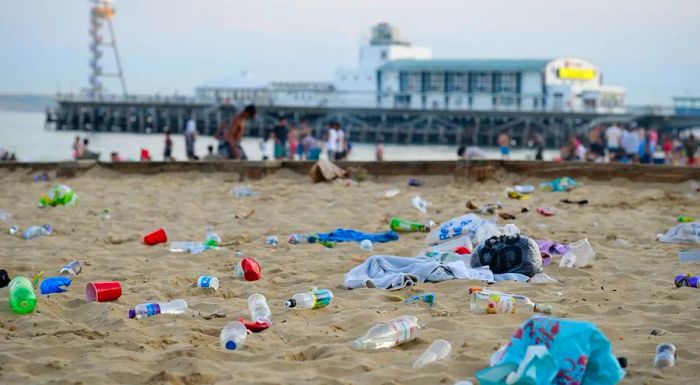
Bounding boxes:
[46,95,700,147]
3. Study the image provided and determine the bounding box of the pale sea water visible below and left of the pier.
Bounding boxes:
[0,110,556,161]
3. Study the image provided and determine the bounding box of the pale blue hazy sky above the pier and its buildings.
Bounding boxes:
[0,0,700,105]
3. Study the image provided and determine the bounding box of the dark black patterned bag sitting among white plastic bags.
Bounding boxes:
[471,234,542,277]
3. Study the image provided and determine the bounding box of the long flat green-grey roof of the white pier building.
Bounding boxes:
[379,59,551,72]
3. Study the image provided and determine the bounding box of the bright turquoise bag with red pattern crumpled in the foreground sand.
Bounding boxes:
[476,316,625,385]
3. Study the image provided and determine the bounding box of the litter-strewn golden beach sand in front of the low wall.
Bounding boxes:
[0,168,700,385]
